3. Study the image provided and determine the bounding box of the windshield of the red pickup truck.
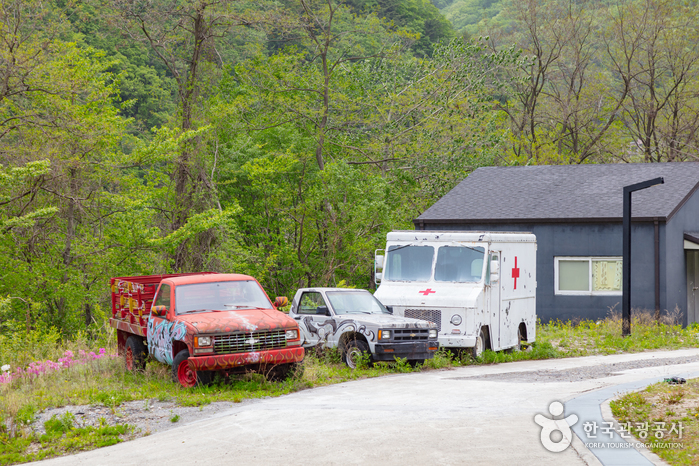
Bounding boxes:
[175,280,272,314]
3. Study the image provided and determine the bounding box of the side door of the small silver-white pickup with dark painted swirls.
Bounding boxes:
[294,291,337,347]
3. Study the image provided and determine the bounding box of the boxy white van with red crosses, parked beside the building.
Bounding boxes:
[374,230,536,357]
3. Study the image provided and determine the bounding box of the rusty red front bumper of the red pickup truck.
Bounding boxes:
[189,346,305,371]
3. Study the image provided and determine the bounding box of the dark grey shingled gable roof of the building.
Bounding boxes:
[414,162,699,225]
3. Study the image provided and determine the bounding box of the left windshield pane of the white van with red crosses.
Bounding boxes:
[384,245,434,282]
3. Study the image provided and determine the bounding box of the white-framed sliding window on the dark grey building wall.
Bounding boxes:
[555,257,622,295]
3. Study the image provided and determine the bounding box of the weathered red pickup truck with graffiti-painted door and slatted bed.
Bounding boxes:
[109,272,304,387]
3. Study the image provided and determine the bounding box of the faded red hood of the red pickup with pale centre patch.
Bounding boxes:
[177,309,297,334]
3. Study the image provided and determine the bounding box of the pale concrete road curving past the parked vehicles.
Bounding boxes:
[34,349,699,466]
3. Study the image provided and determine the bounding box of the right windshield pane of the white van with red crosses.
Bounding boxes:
[434,246,485,283]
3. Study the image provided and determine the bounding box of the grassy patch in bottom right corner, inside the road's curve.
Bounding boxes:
[610,379,699,465]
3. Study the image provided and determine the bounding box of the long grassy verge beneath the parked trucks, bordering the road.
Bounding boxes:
[0,313,699,465]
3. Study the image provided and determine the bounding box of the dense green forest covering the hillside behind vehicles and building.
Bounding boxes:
[0,0,699,337]
